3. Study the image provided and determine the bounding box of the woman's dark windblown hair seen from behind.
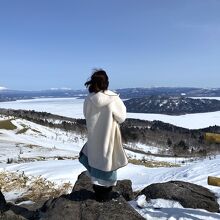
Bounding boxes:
[84,69,109,93]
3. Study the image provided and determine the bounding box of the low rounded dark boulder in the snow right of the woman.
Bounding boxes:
[139,181,219,212]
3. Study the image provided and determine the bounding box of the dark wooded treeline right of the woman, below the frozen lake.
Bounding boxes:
[121,119,220,156]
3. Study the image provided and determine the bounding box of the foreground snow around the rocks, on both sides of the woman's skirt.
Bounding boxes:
[0,156,220,220]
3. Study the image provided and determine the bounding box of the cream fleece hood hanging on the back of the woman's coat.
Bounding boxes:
[90,90,118,107]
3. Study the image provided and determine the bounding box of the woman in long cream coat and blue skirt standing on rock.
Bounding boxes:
[79,70,128,201]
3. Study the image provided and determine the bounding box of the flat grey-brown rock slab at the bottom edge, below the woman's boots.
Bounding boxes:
[40,191,144,220]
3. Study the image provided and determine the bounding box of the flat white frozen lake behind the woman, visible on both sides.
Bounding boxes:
[0,97,220,129]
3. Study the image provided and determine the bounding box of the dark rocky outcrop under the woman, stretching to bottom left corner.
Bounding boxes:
[0,172,144,220]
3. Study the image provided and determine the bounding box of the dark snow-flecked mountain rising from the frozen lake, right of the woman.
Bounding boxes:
[124,96,220,115]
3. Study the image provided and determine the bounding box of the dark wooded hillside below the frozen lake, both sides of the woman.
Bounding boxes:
[0,109,220,157]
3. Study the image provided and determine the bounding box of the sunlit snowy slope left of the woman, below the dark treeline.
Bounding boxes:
[0,116,86,162]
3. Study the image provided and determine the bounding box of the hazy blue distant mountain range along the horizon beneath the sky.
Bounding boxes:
[0,87,220,101]
